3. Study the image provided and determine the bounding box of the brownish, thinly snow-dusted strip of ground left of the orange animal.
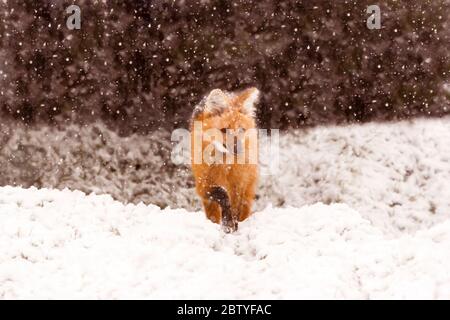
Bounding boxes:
[0,125,196,208]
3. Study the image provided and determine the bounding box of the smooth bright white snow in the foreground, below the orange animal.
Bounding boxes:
[0,187,450,299]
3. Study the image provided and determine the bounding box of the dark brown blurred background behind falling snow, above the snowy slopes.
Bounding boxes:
[0,0,450,135]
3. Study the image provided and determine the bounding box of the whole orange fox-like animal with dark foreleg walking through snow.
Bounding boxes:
[191,88,259,233]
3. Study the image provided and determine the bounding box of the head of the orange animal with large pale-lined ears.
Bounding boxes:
[192,88,259,163]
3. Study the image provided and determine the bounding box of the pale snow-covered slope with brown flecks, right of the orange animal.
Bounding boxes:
[259,118,450,235]
